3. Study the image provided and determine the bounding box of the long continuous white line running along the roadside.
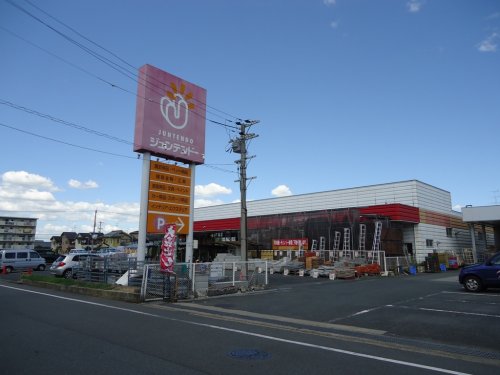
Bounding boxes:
[0,285,470,375]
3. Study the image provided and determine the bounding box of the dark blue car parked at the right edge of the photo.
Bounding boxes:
[458,252,500,292]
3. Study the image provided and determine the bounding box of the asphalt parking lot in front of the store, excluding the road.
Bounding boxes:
[177,271,500,360]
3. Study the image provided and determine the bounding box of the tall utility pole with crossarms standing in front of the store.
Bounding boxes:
[232,120,259,262]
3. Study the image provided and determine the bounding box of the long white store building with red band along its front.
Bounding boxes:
[194,180,487,262]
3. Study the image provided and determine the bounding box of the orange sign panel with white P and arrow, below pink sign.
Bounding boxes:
[147,161,191,234]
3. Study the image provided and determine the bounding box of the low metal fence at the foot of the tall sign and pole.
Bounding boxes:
[141,260,268,302]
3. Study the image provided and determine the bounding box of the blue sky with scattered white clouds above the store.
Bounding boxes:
[0,0,500,239]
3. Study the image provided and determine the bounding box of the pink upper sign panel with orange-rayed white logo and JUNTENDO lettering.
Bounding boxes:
[134,65,207,164]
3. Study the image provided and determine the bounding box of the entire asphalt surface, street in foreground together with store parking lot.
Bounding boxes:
[0,272,500,374]
